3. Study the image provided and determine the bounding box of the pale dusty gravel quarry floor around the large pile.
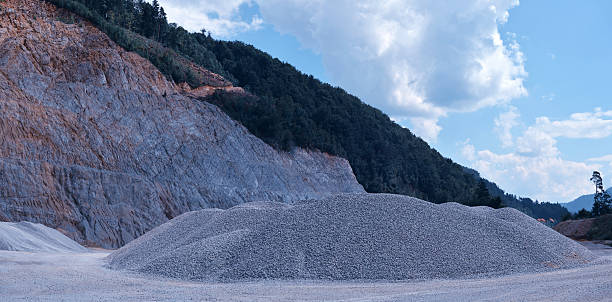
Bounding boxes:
[0,243,612,301]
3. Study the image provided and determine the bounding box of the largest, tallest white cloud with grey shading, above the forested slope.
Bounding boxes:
[258,0,527,140]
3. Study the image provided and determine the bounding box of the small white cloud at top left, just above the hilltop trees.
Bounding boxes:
[159,0,263,38]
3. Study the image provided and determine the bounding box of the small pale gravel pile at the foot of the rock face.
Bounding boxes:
[0,222,87,253]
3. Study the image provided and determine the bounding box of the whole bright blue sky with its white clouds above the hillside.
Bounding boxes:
[160,0,612,202]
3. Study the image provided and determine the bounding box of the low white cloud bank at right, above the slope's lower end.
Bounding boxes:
[462,108,612,201]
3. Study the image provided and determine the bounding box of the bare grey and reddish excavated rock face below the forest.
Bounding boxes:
[0,0,363,248]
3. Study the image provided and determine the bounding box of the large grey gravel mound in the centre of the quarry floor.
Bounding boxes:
[108,194,595,281]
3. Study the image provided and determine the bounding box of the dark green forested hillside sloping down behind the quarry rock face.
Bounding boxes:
[47,0,564,217]
